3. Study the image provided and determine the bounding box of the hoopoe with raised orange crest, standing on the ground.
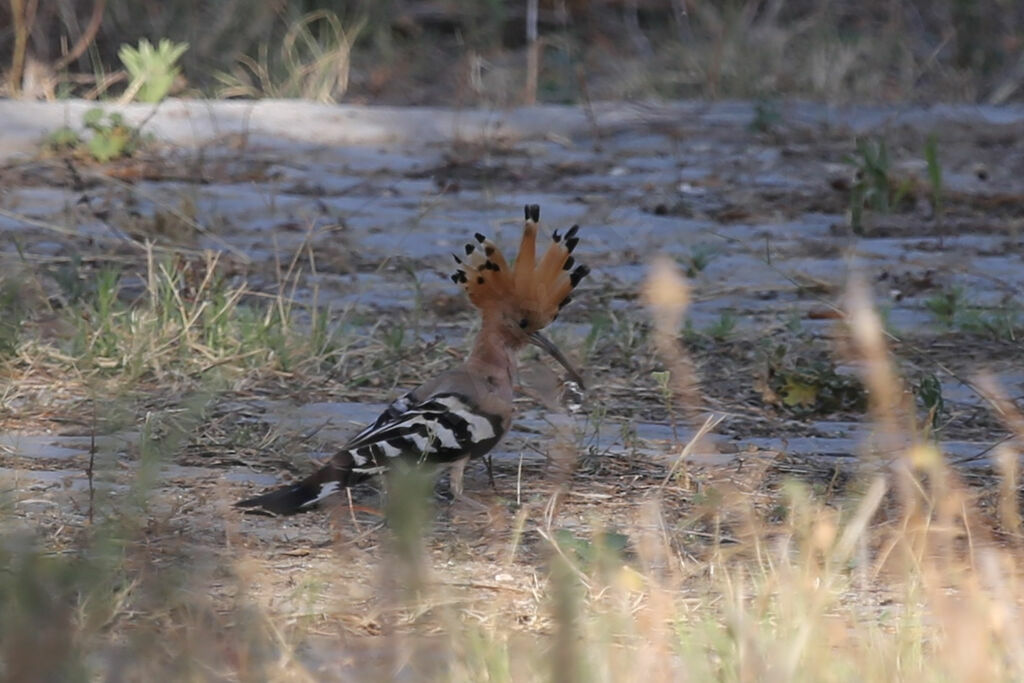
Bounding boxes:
[236,204,590,514]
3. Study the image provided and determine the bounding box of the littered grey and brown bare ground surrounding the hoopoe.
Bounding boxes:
[0,97,1024,678]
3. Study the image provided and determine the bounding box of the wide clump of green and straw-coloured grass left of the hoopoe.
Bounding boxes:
[18,248,345,381]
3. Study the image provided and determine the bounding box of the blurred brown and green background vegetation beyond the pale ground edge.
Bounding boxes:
[0,0,1024,105]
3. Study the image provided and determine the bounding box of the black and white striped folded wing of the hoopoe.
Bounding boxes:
[344,393,505,474]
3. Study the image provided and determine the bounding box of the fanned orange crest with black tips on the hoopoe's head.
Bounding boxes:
[452,204,590,332]
